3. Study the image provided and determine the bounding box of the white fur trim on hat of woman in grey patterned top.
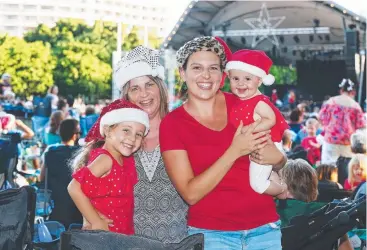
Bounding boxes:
[114,61,164,89]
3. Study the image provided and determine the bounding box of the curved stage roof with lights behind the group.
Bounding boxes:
[162,1,366,59]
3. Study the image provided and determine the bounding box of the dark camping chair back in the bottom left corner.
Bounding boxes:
[0,186,36,250]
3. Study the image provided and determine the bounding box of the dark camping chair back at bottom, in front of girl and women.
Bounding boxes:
[60,230,204,250]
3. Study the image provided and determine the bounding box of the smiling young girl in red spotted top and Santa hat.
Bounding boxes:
[68,100,149,235]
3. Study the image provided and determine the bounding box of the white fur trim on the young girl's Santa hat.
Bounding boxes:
[99,108,149,136]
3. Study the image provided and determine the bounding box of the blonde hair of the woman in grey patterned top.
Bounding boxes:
[121,75,169,119]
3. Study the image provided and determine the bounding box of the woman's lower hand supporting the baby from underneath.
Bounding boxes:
[251,140,287,170]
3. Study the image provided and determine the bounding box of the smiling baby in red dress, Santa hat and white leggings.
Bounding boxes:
[226,50,289,196]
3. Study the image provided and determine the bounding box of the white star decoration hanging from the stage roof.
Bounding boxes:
[244,3,285,48]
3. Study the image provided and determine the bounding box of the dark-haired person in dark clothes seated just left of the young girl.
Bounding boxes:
[41,119,83,228]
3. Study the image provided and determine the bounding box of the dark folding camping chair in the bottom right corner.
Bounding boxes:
[282,196,366,250]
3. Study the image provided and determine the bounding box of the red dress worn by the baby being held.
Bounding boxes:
[229,95,289,142]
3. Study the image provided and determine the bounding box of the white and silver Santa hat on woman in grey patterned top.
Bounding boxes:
[114,45,164,89]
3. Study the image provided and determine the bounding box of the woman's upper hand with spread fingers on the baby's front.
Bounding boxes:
[230,119,270,158]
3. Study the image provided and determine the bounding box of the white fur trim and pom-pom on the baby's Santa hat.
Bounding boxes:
[225,61,275,86]
